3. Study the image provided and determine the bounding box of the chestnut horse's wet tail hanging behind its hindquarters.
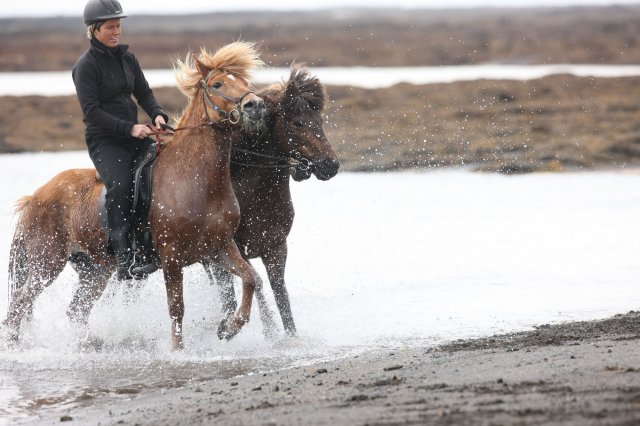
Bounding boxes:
[8,195,31,303]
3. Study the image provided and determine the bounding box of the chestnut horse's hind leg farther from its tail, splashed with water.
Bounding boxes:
[67,253,113,325]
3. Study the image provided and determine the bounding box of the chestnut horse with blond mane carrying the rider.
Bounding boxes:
[5,42,264,349]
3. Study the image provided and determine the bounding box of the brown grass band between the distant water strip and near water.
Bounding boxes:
[0,75,640,173]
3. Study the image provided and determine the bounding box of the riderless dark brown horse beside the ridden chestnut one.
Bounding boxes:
[204,65,340,335]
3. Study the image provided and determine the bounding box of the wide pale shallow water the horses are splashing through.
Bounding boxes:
[0,152,640,425]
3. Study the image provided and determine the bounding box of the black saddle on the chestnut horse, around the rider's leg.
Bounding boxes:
[96,143,160,263]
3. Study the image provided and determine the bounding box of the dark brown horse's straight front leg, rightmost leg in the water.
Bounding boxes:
[262,242,297,336]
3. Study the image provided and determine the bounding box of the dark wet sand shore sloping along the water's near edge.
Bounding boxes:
[39,312,640,425]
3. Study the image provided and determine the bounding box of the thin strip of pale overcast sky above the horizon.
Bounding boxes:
[0,0,640,17]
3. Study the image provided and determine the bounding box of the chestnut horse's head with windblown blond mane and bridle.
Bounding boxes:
[175,42,265,128]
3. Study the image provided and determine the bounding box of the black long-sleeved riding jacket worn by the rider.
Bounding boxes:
[71,39,169,138]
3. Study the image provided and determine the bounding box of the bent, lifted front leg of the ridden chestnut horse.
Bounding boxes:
[218,241,258,340]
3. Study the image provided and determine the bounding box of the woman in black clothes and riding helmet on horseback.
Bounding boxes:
[72,0,168,280]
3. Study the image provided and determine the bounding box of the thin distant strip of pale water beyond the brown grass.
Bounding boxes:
[0,64,640,96]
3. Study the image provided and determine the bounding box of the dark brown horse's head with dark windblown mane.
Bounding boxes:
[260,64,340,181]
